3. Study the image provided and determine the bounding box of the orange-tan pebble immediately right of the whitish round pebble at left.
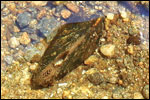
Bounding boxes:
[20,32,31,45]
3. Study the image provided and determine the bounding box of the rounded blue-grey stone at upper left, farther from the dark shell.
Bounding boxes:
[17,12,31,28]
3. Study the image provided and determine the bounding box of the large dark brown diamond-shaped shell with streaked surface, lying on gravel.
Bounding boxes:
[32,17,104,88]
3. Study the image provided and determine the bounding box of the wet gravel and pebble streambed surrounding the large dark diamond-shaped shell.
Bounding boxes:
[1,1,149,99]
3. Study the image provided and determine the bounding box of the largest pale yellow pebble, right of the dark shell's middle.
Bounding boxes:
[100,44,115,57]
